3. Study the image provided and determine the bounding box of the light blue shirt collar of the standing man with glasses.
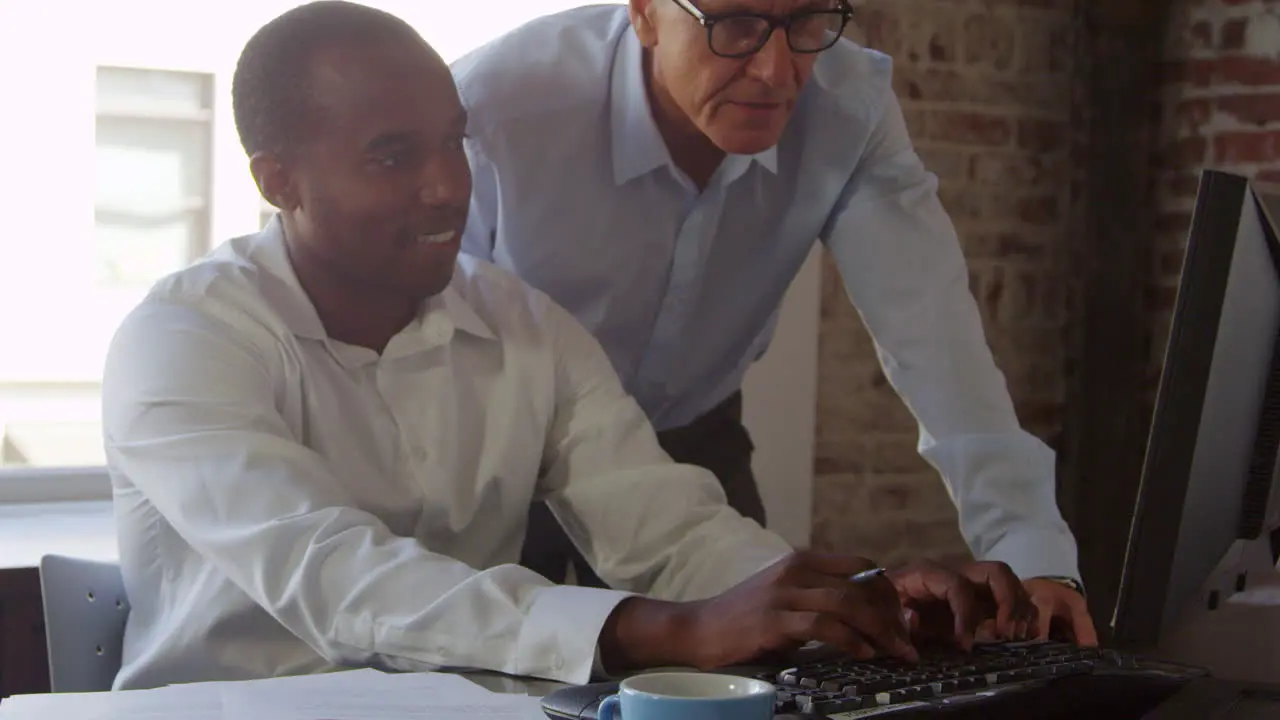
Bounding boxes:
[609,27,778,184]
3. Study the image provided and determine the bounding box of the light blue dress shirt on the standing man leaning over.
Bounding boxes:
[453,5,1078,577]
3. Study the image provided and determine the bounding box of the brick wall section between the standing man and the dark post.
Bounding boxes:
[813,0,1075,562]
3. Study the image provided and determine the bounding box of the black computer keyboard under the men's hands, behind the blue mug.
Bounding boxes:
[543,642,1204,720]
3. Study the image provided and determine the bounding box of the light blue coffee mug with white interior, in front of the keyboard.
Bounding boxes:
[596,673,777,720]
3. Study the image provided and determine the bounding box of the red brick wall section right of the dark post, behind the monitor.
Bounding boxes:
[1148,0,1280,384]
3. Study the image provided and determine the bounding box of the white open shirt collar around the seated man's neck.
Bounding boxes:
[250,215,498,345]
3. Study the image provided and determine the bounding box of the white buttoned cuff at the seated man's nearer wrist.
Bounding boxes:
[512,585,632,685]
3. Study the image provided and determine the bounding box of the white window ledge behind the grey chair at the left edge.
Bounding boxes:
[0,500,119,569]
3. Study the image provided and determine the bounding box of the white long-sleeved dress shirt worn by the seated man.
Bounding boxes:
[102,220,790,688]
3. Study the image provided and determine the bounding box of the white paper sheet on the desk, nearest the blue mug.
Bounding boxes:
[221,685,544,720]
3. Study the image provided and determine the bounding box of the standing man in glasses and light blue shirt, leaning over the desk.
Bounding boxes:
[453,0,1096,643]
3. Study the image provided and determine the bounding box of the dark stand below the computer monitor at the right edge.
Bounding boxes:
[1143,536,1280,684]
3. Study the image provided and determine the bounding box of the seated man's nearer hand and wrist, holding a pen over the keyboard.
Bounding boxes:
[600,551,919,670]
